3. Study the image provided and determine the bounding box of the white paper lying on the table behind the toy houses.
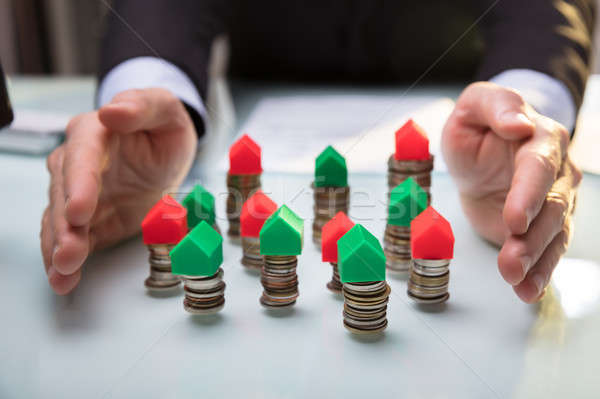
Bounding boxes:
[221,95,454,173]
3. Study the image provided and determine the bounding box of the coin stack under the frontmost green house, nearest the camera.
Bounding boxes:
[342,281,391,334]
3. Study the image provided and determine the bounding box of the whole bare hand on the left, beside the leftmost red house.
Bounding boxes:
[40,89,197,295]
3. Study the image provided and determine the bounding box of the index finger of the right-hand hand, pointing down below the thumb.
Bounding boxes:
[503,131,568,234]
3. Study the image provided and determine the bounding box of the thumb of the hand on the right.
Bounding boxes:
[455,82,535,140]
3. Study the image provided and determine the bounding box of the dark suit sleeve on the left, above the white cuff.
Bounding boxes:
[99,0,227,133]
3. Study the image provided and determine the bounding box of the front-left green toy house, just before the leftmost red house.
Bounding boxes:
[170,220,223,277]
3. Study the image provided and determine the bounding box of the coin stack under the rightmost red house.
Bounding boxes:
[407,259,450,304]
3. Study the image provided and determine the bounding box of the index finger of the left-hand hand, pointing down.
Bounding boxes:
[62,112,109,226]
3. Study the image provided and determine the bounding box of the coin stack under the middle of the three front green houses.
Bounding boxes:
[260,255,299,308]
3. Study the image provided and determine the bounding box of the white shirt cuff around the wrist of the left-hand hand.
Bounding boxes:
[97,57,206,126]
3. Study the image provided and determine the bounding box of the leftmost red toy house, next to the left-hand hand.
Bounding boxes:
[142,195,188,245]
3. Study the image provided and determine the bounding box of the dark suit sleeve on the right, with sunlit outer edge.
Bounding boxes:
[477,0,596,110]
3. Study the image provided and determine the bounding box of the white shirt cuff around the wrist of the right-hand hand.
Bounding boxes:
[490,69,576,131]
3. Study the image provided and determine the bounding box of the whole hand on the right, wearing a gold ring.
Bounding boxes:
[442,82,582,303]
